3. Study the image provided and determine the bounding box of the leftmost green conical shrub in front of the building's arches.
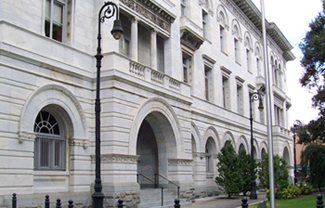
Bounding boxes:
[215,143,242,198]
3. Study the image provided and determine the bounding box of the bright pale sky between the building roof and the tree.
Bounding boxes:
[252,0,322,127]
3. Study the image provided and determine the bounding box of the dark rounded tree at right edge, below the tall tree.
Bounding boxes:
[301,144,325,190]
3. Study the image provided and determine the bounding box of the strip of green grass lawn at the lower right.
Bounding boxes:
[249,196,317,208]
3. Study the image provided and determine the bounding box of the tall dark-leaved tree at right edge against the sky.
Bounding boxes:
[298,0,325,144]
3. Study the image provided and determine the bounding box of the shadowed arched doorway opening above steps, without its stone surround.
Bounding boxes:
[136,112,176,188]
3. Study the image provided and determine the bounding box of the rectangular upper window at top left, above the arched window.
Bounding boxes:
[44,0,67,42]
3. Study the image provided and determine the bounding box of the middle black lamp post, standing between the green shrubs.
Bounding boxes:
[249,86,264,199]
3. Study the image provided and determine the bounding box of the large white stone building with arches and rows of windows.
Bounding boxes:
[0,0,295,207]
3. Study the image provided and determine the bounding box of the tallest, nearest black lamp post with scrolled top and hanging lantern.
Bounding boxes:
[92,2,123,208]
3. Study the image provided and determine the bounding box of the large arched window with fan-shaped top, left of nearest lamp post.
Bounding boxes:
[34,110,66,170]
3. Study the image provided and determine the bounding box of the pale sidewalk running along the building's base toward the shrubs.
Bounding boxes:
[181,192,267,208]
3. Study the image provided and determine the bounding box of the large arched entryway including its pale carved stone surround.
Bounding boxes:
[130,98,183,187]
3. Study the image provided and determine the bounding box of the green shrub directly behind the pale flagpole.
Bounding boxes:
[257,154,289,190]
